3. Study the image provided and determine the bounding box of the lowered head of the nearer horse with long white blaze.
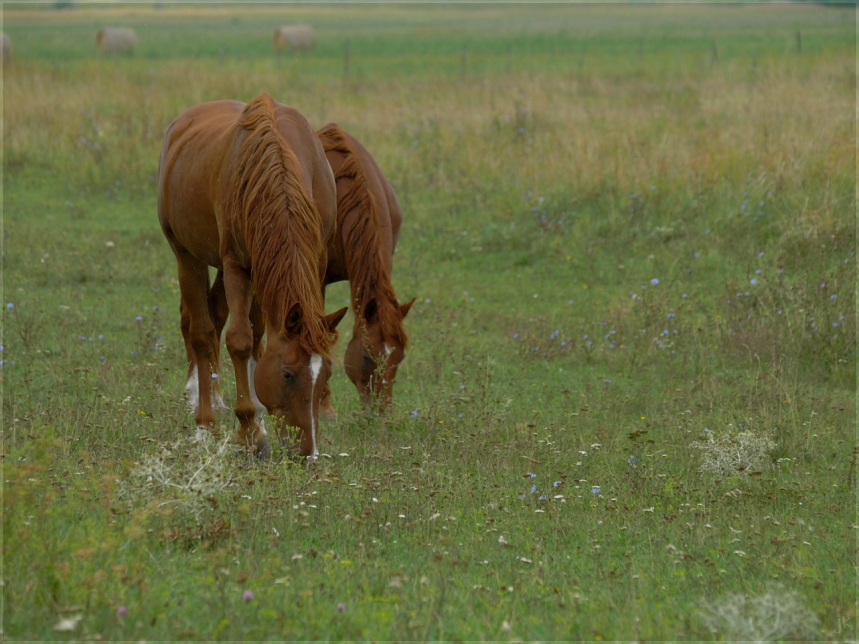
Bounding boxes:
[254,308,346,460]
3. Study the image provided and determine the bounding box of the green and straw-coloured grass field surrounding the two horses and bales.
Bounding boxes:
[0,4,857,640]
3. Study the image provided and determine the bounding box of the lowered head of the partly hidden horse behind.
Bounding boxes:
[343,300,414,406]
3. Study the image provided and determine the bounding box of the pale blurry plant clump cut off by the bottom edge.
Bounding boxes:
[699,585,820,642]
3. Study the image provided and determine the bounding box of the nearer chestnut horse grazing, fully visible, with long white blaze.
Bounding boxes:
[158,94,346,460]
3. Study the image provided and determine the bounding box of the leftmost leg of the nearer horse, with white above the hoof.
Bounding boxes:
[176,250,218,438]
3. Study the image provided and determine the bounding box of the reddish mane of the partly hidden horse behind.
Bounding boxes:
[316,123,408,347]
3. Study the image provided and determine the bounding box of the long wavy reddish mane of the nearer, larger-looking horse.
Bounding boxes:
[226,94,336,356]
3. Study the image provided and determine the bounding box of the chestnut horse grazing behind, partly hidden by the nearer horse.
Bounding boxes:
[316,123,414,405]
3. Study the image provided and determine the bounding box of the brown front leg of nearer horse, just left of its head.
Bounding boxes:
[224,257,269,456]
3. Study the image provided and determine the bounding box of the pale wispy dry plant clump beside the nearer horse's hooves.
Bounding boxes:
[120,438,235,522]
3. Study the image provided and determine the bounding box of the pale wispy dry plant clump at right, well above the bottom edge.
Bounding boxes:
[695,431,775,478]
